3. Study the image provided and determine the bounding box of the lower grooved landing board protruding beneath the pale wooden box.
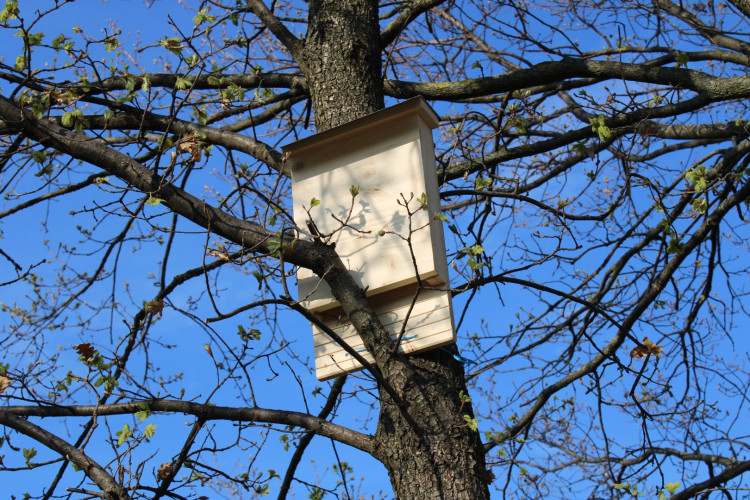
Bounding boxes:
[313,290,456,380]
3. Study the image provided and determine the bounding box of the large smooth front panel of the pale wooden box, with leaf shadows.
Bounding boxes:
[293,119,444,310]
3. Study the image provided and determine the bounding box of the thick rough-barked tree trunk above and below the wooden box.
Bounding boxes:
[301,0,489,500]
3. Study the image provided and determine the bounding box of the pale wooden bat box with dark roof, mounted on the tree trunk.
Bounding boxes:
[283,98,455,380]
